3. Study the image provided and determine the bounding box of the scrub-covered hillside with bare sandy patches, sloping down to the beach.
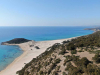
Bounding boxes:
[16,31,100,75]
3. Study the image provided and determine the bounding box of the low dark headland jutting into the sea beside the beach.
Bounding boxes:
[1,38,31,45]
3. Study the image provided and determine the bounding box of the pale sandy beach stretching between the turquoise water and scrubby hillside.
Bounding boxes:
[0,37,75,75]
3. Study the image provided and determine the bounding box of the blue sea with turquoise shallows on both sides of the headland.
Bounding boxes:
[0,26,93,70]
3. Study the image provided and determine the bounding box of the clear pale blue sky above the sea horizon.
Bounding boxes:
[0,0,100,26]
